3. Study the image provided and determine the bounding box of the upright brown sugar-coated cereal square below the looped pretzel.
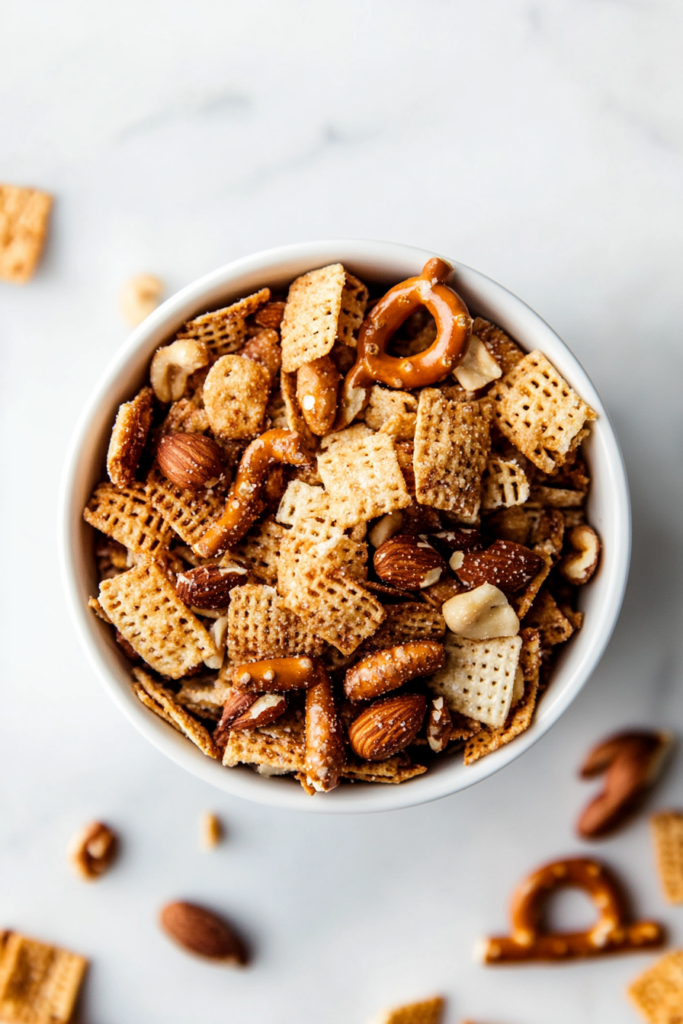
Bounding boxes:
[413,388,490,522]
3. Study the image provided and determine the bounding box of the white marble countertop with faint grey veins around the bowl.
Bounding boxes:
[0,0,683,1024]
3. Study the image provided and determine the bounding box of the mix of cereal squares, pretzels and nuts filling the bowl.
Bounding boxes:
[84,258,600,794]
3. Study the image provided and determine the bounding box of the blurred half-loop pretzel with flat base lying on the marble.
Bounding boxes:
[480,857,665,965]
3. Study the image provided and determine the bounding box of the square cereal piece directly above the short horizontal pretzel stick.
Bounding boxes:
[227,584,323,663]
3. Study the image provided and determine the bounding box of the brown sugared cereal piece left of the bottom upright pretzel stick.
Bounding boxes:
[223,711,304,775]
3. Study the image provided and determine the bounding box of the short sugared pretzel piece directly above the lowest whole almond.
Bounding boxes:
[344,640,445,700]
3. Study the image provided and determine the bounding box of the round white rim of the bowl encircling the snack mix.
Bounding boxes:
[58,239,631,814]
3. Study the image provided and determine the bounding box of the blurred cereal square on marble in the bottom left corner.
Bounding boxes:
[0,932,88,1024]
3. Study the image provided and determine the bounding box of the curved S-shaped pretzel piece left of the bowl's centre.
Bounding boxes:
[195,430,311,558]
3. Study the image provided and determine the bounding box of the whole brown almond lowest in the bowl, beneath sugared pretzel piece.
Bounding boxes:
[348,693,427,761]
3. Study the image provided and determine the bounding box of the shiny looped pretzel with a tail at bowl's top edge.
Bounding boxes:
[335,257,472,430]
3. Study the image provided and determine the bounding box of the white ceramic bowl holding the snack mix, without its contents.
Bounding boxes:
[60,240,631,813]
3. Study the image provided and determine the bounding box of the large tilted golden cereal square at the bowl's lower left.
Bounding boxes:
[99,561,218,679]
